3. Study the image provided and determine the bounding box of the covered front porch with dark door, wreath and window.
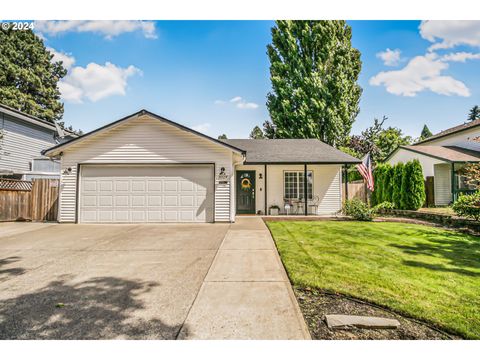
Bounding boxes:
[233,163,346,218]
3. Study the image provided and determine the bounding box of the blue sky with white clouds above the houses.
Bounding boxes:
[35,21,480,138]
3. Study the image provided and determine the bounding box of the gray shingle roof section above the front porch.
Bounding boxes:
[222,139,360,164]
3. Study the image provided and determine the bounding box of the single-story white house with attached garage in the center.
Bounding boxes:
[44,110,360,223]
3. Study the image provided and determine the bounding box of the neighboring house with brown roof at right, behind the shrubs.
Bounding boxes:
[386,119,480,206]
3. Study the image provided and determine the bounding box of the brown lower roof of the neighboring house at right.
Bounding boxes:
[400,145,480,162]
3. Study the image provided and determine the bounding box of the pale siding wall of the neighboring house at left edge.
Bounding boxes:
[0,114,55,171]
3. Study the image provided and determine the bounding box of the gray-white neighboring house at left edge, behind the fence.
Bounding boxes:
[0,104,76,180]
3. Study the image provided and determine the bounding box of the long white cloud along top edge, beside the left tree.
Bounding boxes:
[35,20,157,39]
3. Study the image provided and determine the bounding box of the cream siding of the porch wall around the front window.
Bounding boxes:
[237,165,342,215]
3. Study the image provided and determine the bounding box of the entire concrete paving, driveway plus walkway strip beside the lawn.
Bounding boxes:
[0,219,308,339]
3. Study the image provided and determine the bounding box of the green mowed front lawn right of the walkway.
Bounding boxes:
[267,221,480,339]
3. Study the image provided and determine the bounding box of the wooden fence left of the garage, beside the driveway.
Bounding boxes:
[0,179,59,221]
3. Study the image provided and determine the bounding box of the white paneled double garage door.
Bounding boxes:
[79,165,214,223]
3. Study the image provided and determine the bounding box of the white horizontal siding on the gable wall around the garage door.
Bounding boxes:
[59,115,236,222]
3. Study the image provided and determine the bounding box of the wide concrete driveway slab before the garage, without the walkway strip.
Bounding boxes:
[0,223,229,339]
